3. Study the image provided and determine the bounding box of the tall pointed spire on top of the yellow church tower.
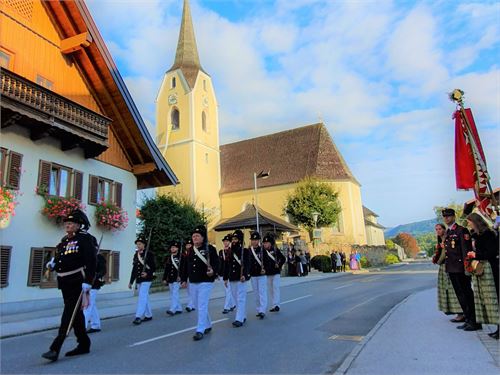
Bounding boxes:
[167,0,203,89]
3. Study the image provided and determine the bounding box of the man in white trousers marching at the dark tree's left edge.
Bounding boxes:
[128,236,156,325]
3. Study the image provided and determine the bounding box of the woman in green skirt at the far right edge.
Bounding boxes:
[467,212,499,340]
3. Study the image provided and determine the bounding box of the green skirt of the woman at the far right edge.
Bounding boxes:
[472,260,499,324]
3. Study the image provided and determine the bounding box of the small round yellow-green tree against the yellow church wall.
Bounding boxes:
[283,177,341,238]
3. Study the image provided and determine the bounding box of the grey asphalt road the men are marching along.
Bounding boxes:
[0,263,437,374]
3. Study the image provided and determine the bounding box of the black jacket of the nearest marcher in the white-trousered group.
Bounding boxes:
[181,244,219,283]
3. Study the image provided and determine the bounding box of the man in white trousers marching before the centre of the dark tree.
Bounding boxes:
[163,241,182,316]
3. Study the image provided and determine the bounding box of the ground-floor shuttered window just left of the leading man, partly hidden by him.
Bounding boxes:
[28,247,57,288]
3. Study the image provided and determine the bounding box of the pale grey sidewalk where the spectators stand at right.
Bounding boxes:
[335,288,500,375]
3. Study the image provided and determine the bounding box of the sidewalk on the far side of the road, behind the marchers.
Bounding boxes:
[0,270,351,338]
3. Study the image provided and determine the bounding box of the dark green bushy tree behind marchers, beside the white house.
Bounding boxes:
[139,194,206,265]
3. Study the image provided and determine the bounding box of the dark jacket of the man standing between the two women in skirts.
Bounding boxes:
[444,223,472,273]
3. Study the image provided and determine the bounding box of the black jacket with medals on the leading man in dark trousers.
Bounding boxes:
[54,230,97,289]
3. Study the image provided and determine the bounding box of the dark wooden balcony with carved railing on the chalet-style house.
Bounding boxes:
[0,69,111,158]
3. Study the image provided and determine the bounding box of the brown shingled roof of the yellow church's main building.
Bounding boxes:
[220,123,359,193]
